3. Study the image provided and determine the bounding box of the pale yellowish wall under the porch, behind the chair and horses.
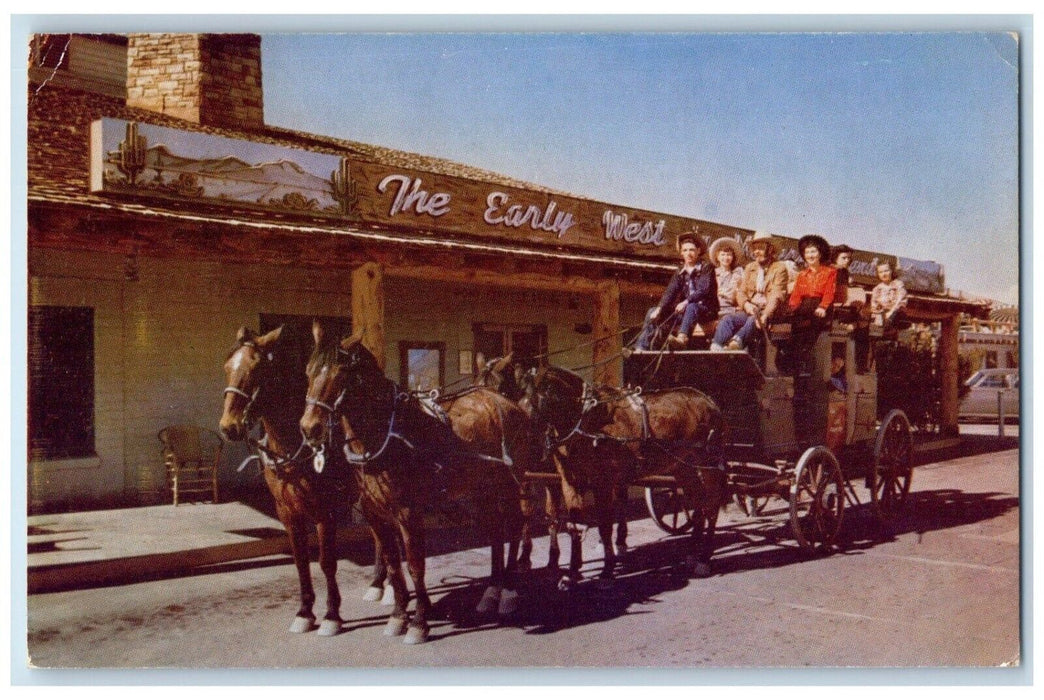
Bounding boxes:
[28,250,645,510]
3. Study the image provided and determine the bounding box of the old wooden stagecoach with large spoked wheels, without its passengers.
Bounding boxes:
[624,322,912,551]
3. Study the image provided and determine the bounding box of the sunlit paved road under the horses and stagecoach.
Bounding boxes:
[22,450,1020,680]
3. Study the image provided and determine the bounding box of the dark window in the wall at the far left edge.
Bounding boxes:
[28,306,94,460]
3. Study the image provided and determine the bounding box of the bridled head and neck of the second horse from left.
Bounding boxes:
[301,321,388,444]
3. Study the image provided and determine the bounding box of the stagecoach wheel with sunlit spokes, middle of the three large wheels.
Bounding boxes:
[790,446,845,551]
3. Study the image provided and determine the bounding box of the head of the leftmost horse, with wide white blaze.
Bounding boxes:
[219,326,283,441]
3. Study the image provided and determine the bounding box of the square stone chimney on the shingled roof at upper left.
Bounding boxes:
[127,33,264,129]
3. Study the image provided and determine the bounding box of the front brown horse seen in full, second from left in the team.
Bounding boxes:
[301,324,529,644]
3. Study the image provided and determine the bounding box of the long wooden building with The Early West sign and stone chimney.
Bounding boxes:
[28,34,984,510]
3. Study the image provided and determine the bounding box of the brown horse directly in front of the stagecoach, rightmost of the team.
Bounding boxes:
[531,367,728,580]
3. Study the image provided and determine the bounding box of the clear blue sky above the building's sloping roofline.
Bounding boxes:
[262,31,1019,302]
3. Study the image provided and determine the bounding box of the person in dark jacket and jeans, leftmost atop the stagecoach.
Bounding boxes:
[637,231,718,350]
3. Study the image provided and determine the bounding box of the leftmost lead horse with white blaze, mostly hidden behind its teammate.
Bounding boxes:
[220,327,367,636]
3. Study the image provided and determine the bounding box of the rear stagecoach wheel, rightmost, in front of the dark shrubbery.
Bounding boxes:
[867,409,914,522]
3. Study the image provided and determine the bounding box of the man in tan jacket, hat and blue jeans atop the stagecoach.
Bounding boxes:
[711,231,787,350]
